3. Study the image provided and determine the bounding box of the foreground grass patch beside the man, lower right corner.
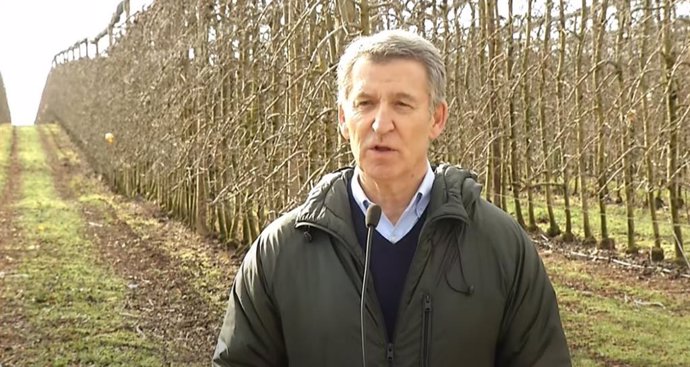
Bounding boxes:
[544,257,690,367]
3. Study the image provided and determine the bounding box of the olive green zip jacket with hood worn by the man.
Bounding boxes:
[213,165,571,367]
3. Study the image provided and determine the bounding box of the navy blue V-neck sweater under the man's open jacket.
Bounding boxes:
[347,183,426,341]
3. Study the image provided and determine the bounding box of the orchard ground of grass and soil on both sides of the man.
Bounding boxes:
[0,125,690,367]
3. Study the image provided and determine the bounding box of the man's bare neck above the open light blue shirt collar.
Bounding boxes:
[359,163,428,225]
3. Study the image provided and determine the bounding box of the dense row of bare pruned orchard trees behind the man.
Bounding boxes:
[38,0,690,259]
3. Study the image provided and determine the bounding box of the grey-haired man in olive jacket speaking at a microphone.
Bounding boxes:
[213,31,570,367]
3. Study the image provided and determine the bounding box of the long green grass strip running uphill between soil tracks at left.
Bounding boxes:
[7,127,162,366]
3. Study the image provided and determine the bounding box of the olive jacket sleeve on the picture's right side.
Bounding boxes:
[496,224,571,367]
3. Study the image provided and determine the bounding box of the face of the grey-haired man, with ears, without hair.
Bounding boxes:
[338,58,448,182]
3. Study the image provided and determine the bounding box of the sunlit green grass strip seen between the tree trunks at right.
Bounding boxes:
[508,196,690,259]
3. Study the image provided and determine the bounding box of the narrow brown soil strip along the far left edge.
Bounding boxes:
[0,128,27,364]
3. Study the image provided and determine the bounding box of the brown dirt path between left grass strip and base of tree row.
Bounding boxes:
[40,124,236,365]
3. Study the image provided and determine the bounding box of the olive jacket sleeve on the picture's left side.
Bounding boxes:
[213,236,287,367]
